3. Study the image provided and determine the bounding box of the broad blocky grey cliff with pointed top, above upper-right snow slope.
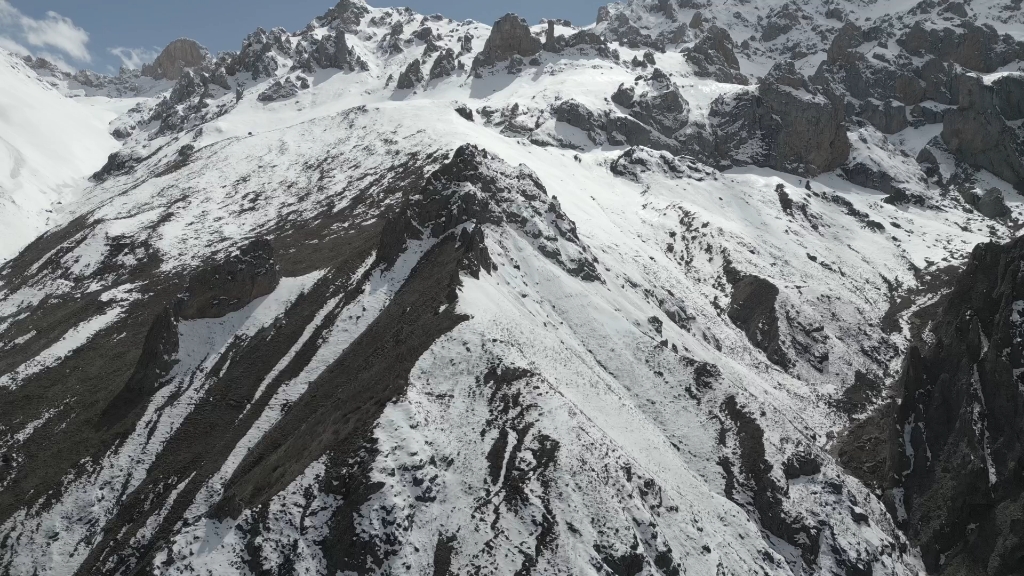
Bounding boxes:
[709,60,850,175]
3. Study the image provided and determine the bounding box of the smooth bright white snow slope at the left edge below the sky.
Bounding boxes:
[0,50,118,261]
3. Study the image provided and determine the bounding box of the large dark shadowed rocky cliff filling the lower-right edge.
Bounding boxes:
[841,239,1024,576]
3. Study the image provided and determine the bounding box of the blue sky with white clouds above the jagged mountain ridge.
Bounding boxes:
[0,0,608,72]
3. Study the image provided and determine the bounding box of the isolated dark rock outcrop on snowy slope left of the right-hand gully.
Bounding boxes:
[728,276,793,369]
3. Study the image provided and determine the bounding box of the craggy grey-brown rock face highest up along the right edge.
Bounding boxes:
[896,19,1022,73]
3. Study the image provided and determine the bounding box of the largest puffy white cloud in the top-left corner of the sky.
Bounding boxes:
[0,0,92,63]
